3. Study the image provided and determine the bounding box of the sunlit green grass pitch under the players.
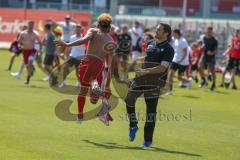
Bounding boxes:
[0,50,240,160]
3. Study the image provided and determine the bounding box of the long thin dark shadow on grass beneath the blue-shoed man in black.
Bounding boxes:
[83,140,202,157]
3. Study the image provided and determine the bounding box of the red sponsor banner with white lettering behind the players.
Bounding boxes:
[0,8,92,42]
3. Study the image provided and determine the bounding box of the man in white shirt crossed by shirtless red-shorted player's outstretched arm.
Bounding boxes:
[60,24,86,88]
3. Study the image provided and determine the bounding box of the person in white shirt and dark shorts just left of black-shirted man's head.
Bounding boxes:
[131,21,143,62]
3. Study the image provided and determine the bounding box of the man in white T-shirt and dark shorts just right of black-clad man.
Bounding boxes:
[168,29,192,95]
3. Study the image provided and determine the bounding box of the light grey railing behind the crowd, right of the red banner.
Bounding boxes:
[115,15,240,53]
